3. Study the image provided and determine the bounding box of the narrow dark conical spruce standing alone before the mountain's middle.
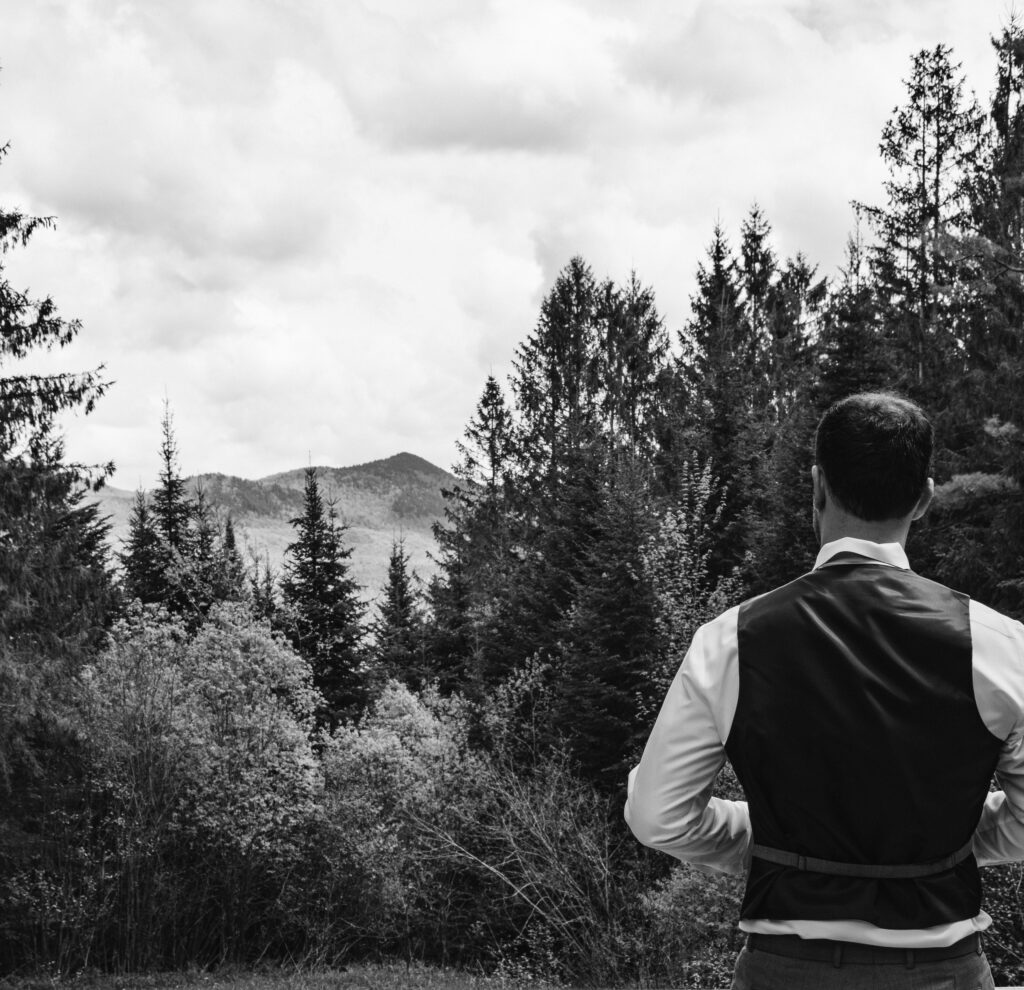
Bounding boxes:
[281,468,367,730]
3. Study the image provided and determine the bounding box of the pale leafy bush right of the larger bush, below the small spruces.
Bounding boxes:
[322,682,489,963]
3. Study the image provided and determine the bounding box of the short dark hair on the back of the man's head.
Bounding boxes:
[814,392,933,521]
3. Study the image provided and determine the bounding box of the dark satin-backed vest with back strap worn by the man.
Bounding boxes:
[726,554,1001,929]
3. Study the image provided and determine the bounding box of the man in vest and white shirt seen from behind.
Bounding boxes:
[626,394,1024,990]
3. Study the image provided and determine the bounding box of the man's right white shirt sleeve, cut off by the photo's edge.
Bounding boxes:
[971,602,1024,866]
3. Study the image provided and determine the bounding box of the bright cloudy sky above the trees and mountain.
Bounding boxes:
[0,0,1012,488]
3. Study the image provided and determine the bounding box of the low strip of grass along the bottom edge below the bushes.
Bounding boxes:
[0,962,550,990]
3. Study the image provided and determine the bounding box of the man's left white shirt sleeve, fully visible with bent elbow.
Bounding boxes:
[626,609,751,874]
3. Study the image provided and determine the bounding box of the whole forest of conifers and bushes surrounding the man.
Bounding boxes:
[0,18,1024,987]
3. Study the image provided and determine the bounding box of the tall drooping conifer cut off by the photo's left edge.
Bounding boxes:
[0,146,113,790]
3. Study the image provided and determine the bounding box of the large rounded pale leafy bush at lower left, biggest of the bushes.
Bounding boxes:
[0,605,322,970]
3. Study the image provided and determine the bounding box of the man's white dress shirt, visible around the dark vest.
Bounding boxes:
[626,537,1024,948]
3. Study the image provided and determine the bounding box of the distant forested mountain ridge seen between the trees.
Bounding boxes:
[92,453,456,600]
